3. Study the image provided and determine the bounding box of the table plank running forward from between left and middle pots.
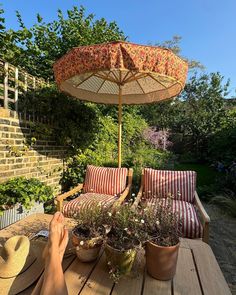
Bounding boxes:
[79,253,114,295]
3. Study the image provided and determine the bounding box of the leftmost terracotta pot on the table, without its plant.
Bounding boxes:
[72,230,103,262]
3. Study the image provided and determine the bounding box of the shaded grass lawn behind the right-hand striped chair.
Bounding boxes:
[175,163,219,186]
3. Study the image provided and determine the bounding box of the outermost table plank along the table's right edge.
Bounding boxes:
[191,240,231,295]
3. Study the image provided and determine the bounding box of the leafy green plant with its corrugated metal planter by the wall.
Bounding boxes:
[0,177,53,228]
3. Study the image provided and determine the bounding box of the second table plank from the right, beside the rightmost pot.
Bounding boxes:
[173,247,202,295]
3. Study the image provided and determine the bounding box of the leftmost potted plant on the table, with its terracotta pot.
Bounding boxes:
[72,205,107,262]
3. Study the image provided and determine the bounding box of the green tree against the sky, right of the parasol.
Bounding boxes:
[182,73,229,159]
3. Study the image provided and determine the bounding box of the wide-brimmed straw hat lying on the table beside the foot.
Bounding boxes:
[0,236,45,295]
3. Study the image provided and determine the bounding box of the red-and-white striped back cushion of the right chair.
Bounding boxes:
[144,168,196,203]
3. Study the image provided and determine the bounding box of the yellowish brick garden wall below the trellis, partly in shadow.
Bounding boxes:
[0,108,66,193]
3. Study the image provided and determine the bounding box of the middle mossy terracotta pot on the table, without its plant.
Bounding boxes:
[105,245,137,275]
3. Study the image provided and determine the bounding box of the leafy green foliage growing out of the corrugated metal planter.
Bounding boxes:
[0,177,53,212]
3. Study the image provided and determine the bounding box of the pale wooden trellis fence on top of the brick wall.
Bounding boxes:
[0,59,47,111]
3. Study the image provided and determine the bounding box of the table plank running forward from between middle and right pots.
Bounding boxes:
[112,250,146,295]
